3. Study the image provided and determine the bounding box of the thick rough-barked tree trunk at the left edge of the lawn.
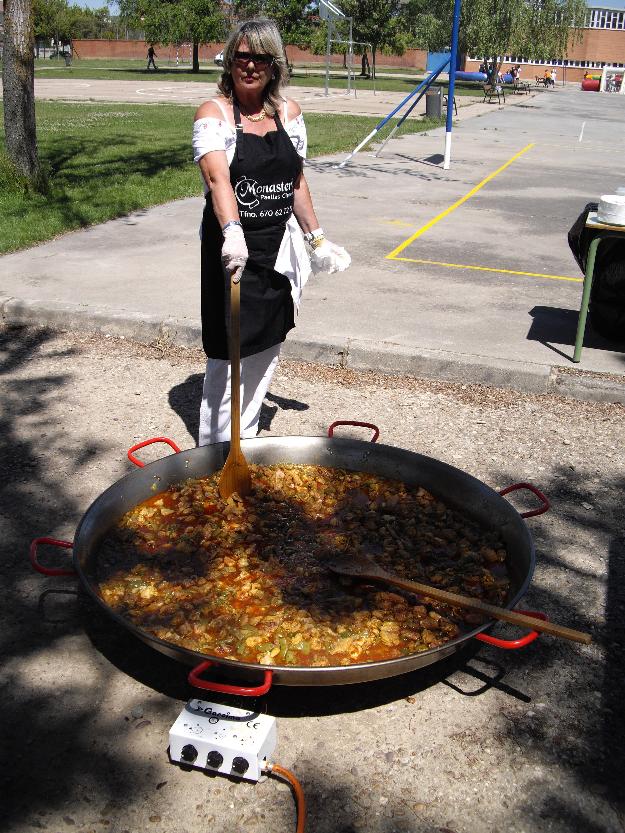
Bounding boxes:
[2,0,39,180]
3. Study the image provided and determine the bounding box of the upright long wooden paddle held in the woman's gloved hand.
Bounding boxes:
[219,269,252,500]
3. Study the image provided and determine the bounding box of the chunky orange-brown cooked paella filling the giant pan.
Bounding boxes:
[97,465,509,667]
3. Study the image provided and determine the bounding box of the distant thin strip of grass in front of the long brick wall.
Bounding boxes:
[29,58,482,96]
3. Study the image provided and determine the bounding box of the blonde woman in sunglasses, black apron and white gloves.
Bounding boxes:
[193,20,350,445]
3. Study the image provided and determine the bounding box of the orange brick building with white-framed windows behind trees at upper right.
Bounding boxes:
[465,0,625,81]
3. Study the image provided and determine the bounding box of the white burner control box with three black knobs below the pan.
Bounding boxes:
[169,699,277,781]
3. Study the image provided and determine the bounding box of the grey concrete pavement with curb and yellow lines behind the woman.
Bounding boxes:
[0,83,625,402]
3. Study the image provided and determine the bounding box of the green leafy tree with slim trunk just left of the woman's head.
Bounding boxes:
[119,0,226,72]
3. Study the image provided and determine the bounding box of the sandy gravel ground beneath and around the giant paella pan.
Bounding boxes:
[0,329,625,833]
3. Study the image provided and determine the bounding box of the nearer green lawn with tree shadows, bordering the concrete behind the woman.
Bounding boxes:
[0,101,437,253]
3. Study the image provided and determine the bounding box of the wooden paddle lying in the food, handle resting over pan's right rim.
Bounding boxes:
[324,553,591,645]
